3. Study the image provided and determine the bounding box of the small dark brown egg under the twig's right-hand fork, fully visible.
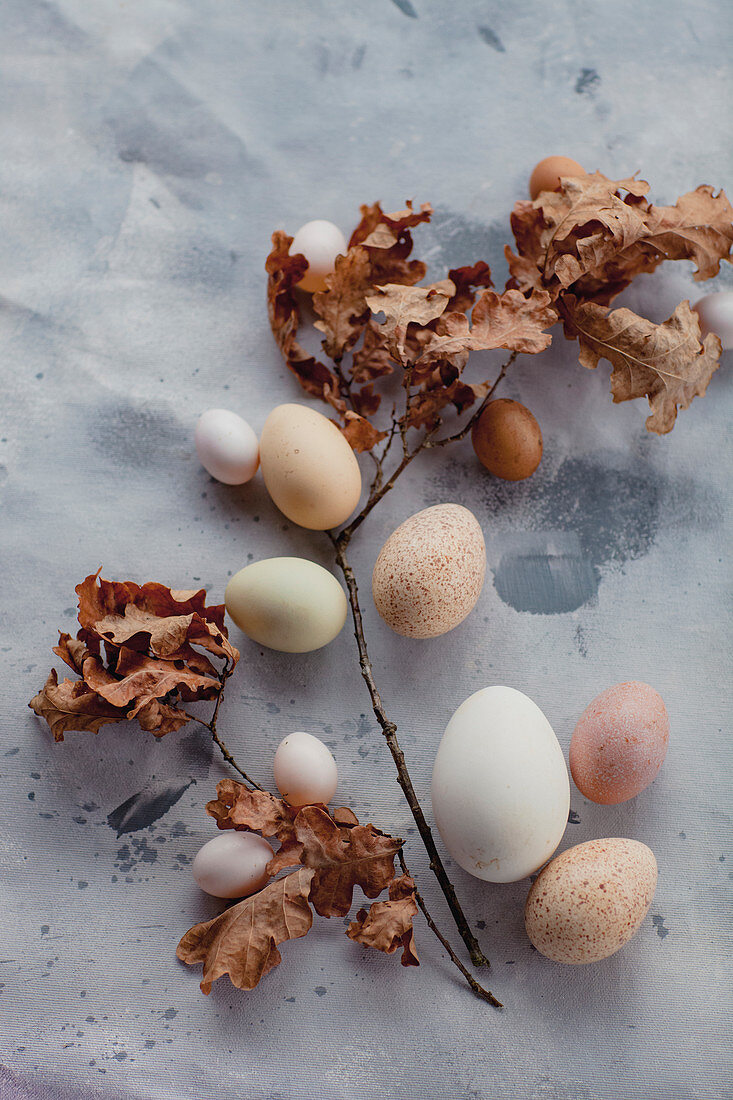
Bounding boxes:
[471,397,543,481]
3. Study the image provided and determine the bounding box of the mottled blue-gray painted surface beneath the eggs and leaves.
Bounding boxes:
[0,0,733,1100]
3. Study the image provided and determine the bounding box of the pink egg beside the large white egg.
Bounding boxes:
[570,680,669,805]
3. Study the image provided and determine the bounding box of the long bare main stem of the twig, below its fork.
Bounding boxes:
[328,532,489,966]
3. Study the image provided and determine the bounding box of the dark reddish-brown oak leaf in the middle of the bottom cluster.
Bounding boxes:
[295,806,402,916]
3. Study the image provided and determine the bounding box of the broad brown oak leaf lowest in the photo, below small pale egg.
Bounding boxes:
[176,867,315,993]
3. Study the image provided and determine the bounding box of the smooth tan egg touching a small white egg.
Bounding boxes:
[260,405,361,531]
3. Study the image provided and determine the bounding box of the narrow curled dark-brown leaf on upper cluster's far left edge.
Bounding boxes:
[265,230,346,413]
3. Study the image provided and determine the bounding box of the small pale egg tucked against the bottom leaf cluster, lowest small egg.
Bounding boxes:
[193,831,274,898]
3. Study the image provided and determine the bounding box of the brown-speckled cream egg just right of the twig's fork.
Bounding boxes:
[372,504,486,638]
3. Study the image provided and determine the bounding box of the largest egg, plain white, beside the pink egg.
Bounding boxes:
[433,686,570,882]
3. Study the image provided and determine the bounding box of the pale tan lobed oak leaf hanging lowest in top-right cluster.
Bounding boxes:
[562,295,721,435]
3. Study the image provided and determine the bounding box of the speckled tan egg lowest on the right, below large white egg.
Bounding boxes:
[524,837,657,964]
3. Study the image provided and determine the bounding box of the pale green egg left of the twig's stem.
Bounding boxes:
[225,558,348,653]
